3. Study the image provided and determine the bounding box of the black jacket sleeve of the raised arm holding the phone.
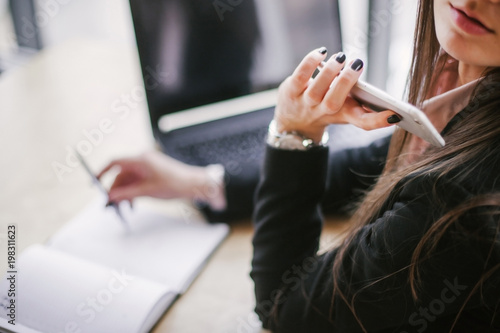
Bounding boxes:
[251,147,499,332]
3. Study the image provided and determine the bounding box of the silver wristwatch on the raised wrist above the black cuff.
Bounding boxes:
[267,119,329,150]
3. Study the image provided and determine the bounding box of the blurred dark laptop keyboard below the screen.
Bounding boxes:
[176,126,267,166]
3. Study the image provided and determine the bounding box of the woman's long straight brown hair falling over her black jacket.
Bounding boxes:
[330,0,500,331]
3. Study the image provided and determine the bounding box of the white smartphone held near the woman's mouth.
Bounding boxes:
[351,80,445,147]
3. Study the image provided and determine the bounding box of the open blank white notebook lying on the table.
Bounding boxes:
[0,201,229,333]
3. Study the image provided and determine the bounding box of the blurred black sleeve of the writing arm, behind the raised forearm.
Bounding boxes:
[200,136,391,222]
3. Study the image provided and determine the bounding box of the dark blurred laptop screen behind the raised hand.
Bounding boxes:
[130,0,341,131]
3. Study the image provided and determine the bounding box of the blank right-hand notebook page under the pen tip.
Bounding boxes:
[49,201,229,293]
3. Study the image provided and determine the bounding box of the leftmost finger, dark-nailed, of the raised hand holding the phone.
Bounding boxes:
[289,47,328,96]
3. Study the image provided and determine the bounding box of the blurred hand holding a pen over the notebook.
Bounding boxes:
[97,152,218,202]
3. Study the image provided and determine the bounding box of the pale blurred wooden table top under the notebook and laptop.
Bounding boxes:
[0,41,346,333]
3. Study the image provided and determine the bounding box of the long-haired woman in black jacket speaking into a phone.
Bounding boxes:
[251,0,500,332]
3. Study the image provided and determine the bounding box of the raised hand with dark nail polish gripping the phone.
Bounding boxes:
[274,48,396,142]
